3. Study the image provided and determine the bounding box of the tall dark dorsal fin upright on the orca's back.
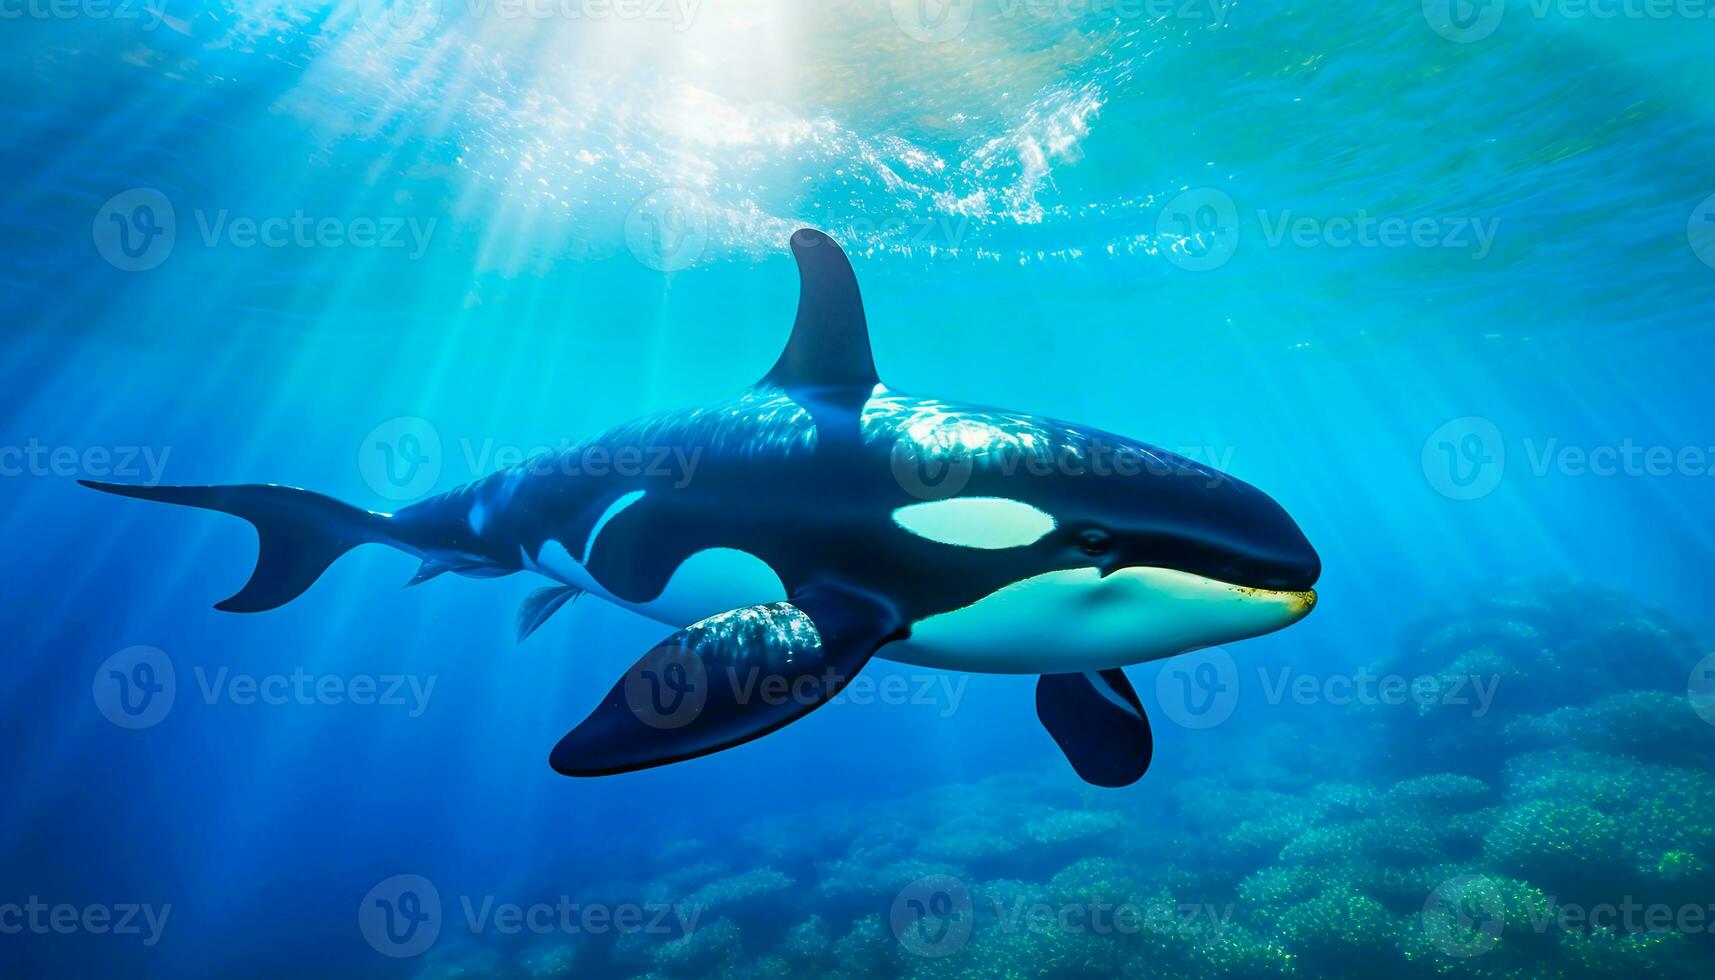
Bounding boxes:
[763,228,878,393]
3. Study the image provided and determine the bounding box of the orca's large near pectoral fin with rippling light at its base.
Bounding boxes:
[549,589,899,776]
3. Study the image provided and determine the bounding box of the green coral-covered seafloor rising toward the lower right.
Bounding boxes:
[408,582,1715,980]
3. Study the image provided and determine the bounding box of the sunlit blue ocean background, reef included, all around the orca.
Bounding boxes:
[0,0,1715,977]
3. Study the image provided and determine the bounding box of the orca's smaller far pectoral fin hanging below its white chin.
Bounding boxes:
[1036,669,1154,788]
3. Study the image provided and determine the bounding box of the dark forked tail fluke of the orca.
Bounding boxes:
[77,481,398,613]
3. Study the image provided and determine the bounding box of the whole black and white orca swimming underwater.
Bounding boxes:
[82,230,1321,786]
